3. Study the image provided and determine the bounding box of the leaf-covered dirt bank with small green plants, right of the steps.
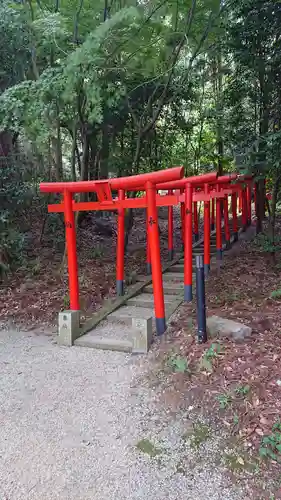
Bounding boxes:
[147,219,281,500]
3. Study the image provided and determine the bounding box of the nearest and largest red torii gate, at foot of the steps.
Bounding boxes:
[40,167,184,335]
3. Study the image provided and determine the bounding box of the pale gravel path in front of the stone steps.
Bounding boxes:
[0,331,245,500]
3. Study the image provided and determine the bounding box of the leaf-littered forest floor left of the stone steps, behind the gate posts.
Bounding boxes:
[0,208,182,329]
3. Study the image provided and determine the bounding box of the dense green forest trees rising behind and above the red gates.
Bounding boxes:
[0,0,281,274]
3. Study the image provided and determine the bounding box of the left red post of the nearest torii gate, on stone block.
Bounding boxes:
[64,190,80,311]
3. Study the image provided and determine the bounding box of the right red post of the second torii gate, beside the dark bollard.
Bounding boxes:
[184,183,192,302]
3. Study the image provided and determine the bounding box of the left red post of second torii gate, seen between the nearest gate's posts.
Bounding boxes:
[116,189,125,296]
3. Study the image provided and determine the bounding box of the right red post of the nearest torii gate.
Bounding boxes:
[146,182,166,335]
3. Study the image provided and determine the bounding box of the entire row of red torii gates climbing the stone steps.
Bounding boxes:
[40,167,256,335]
